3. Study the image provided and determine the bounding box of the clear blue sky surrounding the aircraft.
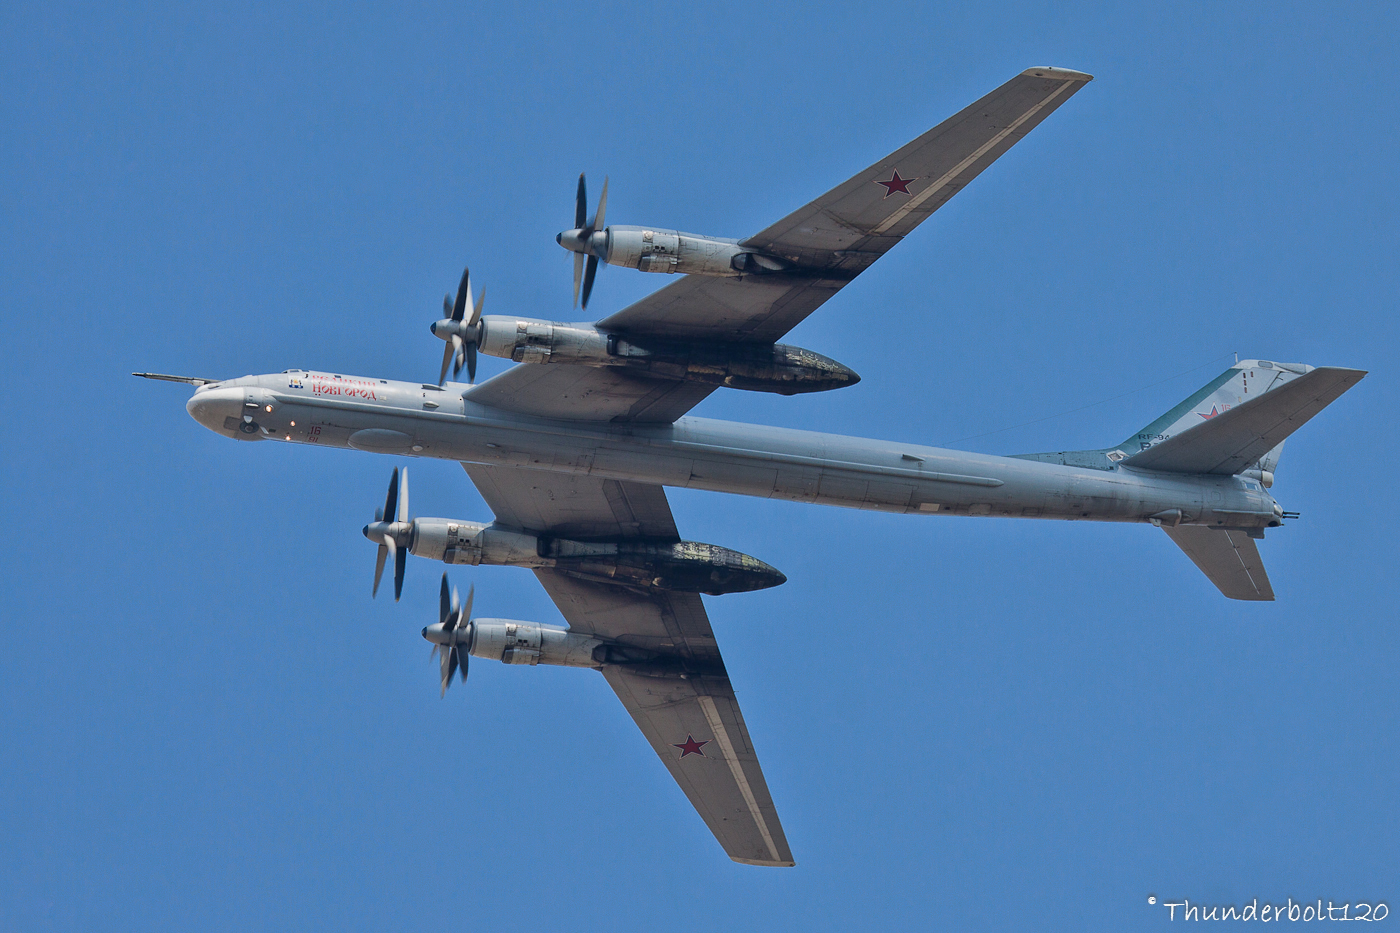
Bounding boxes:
[0,3,1400,932]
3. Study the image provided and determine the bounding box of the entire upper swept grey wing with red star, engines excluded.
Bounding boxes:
[468,69,1092,423]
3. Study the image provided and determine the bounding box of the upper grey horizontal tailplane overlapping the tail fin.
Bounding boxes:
[1123,366,1366,473]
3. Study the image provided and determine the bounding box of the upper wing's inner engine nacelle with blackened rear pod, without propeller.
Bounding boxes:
[479,315,861,395]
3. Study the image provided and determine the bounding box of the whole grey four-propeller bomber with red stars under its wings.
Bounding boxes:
[136,69,1365,866]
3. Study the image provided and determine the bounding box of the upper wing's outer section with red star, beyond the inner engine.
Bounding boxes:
[598,69,1092,342]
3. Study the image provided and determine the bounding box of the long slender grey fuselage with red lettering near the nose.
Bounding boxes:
[186,371,1282,528]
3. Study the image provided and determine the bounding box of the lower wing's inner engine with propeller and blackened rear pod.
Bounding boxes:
[364,469,787,595]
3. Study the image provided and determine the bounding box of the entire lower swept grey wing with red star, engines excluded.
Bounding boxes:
[462,462,794,866]
